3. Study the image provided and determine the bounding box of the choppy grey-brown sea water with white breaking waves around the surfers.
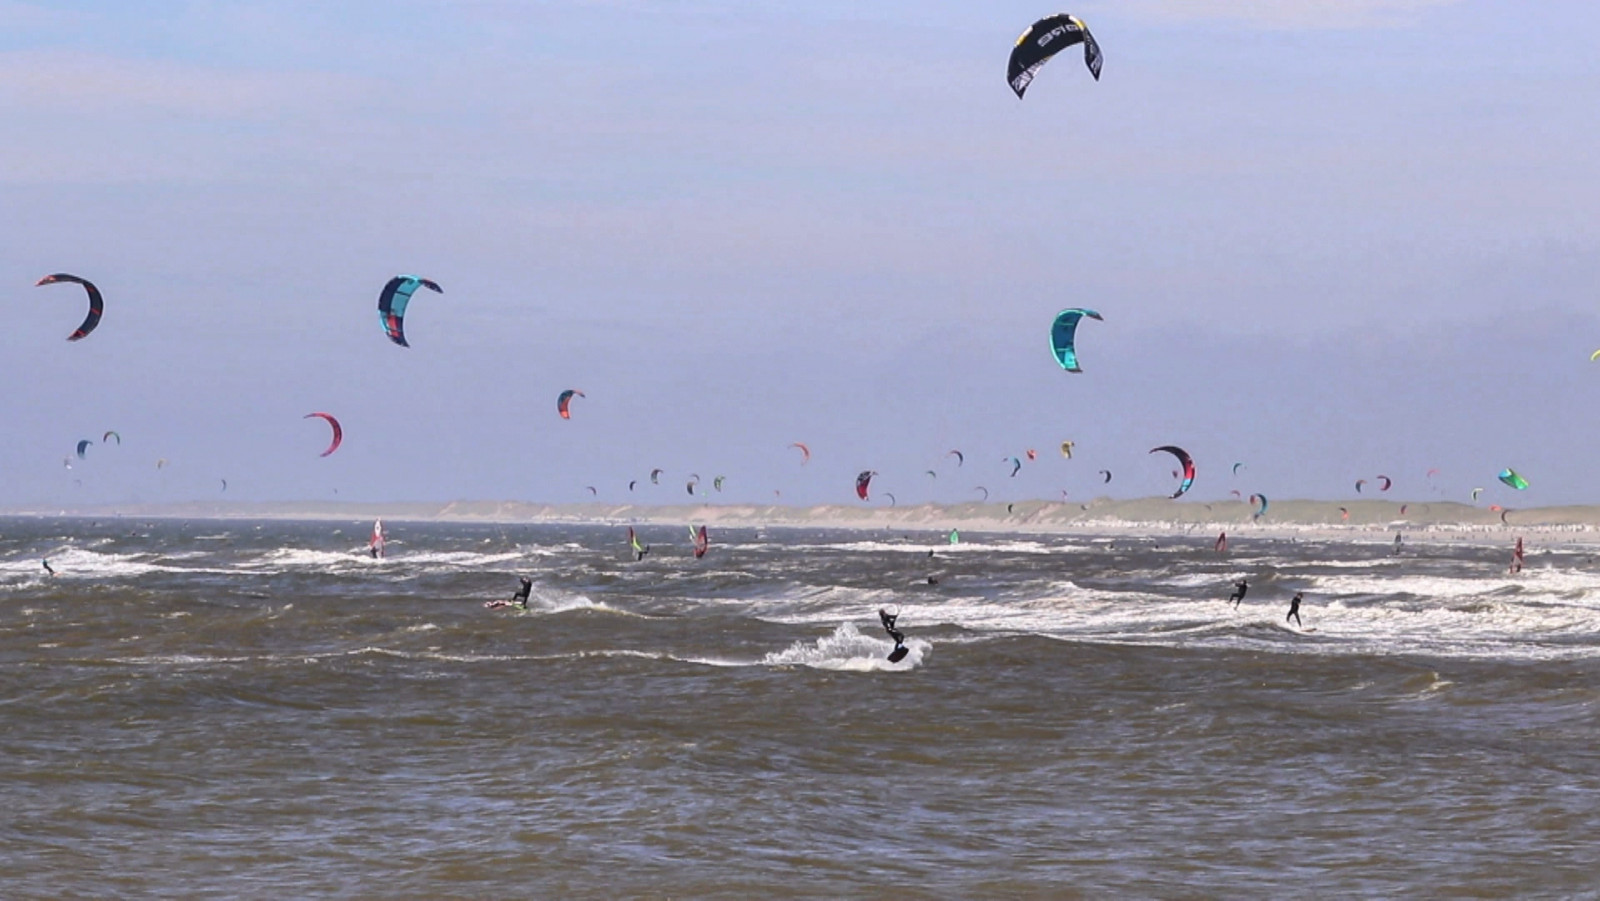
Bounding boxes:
[0,519,1600,898]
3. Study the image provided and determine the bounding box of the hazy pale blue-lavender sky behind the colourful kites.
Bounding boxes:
[0,0,1600,507]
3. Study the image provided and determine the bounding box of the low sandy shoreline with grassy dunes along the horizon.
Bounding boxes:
[0,498,1600,543]
